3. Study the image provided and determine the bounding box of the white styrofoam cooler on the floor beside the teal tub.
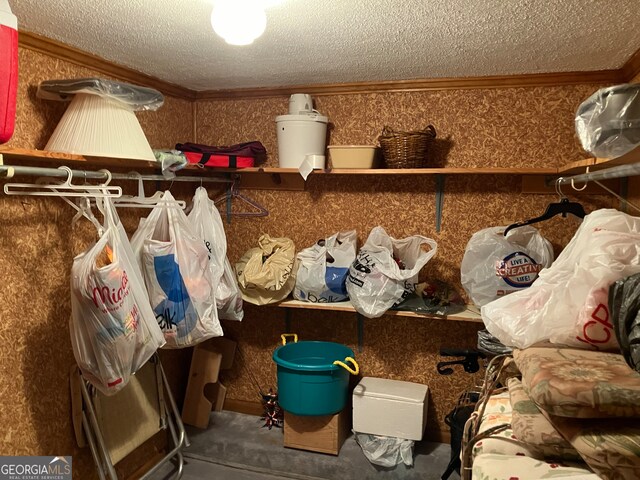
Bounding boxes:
[353,377,429,440]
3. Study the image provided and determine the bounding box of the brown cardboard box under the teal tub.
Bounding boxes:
[284,408,351,455]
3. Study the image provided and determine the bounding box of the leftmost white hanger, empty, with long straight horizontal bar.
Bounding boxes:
[4,167,122,198]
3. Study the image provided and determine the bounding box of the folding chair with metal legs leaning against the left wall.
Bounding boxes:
[71,354,189,480]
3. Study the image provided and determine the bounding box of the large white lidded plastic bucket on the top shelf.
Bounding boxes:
[276,113,328,168]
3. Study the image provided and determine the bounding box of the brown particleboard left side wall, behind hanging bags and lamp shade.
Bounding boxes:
[0,48,193,480]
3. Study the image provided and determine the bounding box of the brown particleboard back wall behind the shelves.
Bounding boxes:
[197,85,613,438]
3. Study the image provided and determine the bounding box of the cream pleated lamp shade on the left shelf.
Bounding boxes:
[45,93,155,161]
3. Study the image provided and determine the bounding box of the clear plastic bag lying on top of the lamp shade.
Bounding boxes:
[36,78,164,111]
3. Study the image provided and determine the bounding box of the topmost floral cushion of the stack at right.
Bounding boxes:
[513,347,640,418]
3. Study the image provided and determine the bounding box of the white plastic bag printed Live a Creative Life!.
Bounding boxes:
[460,225,553,306]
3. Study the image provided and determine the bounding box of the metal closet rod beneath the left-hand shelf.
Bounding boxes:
[0,165,233,183]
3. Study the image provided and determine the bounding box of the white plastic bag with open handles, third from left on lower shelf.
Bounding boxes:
[347,227,438,318]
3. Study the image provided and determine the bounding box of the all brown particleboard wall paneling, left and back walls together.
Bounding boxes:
[0,42,624,480]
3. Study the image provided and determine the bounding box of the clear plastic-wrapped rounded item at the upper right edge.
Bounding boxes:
[575,84,640,158]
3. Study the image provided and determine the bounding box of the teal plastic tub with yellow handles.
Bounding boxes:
[273,334,360,416]
